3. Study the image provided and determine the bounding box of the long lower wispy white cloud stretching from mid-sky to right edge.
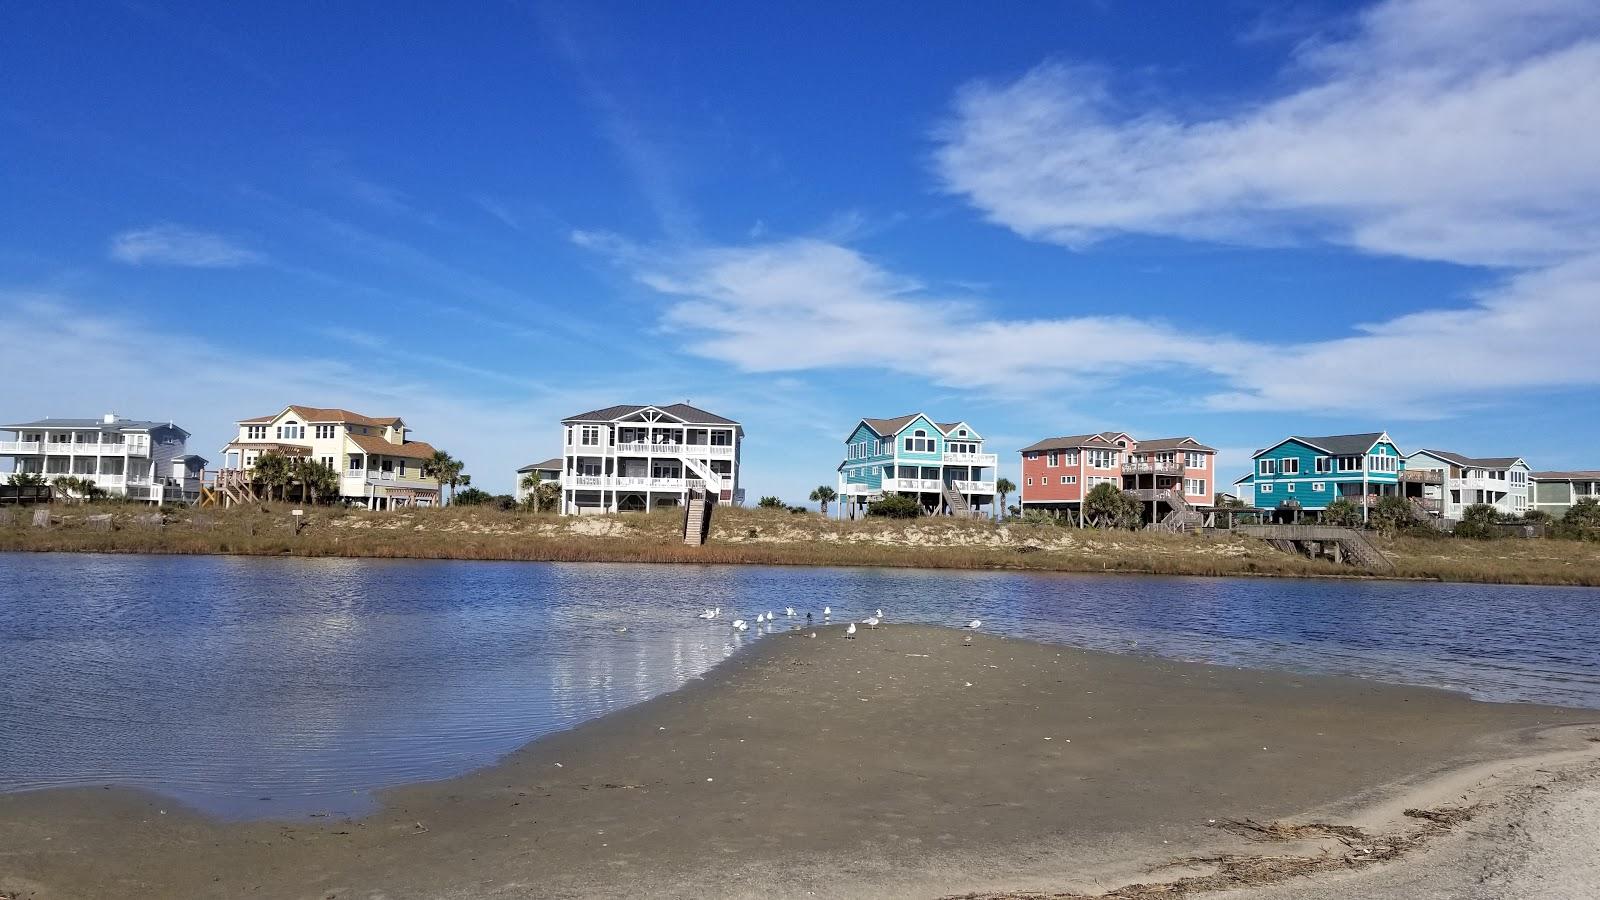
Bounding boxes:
[574,232,1600,418]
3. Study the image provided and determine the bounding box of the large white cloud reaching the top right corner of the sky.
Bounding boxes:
[936,0,1600,264]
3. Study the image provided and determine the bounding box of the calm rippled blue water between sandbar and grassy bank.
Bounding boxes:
[0,554,1600,817]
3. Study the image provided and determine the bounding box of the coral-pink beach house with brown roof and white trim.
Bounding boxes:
[1019,431,1216,525]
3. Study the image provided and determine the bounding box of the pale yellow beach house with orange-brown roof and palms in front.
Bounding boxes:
[218,405,440,509]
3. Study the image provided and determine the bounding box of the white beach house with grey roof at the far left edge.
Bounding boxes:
[0,413,205,503]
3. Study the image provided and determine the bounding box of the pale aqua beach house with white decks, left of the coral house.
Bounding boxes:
[838,413,998,517]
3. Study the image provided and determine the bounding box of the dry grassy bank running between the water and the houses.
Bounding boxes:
[0,504,1600,586]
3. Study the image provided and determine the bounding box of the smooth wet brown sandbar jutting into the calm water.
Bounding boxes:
[0,626,1600,898]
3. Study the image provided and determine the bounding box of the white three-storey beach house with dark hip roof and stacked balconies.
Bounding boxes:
[560,404,744,516]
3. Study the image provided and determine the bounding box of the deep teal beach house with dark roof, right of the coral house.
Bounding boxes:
[1234,431,1405,520]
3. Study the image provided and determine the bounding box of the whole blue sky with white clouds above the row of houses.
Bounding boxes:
[0,0,1600,501]
